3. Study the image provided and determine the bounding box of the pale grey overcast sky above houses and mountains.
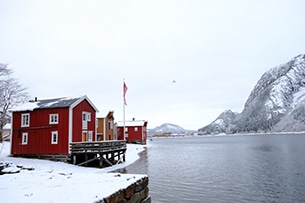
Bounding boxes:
[0,0,305,130]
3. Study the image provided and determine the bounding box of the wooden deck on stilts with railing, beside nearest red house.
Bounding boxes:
[70,141,127,167]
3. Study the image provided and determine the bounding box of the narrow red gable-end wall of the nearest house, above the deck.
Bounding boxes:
[72,100,96,142]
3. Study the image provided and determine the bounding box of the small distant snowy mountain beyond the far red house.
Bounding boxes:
[148,123,191,135]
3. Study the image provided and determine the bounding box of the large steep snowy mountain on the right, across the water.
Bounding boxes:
[198,54,305,134]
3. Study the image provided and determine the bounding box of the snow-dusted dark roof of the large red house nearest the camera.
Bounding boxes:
[12,96,98,111]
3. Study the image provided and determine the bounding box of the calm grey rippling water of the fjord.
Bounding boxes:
[117,134,305,203]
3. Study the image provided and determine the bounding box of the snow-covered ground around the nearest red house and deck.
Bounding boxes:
[0,142,146,203]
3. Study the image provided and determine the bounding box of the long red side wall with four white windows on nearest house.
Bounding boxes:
[11,108,69,155]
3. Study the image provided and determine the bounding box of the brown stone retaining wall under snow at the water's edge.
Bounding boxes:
[96,176,151,203]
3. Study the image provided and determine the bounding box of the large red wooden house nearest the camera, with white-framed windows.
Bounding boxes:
[11,96,98,156]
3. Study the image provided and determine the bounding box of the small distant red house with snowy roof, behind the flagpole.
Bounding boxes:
[116,119,147,144]
